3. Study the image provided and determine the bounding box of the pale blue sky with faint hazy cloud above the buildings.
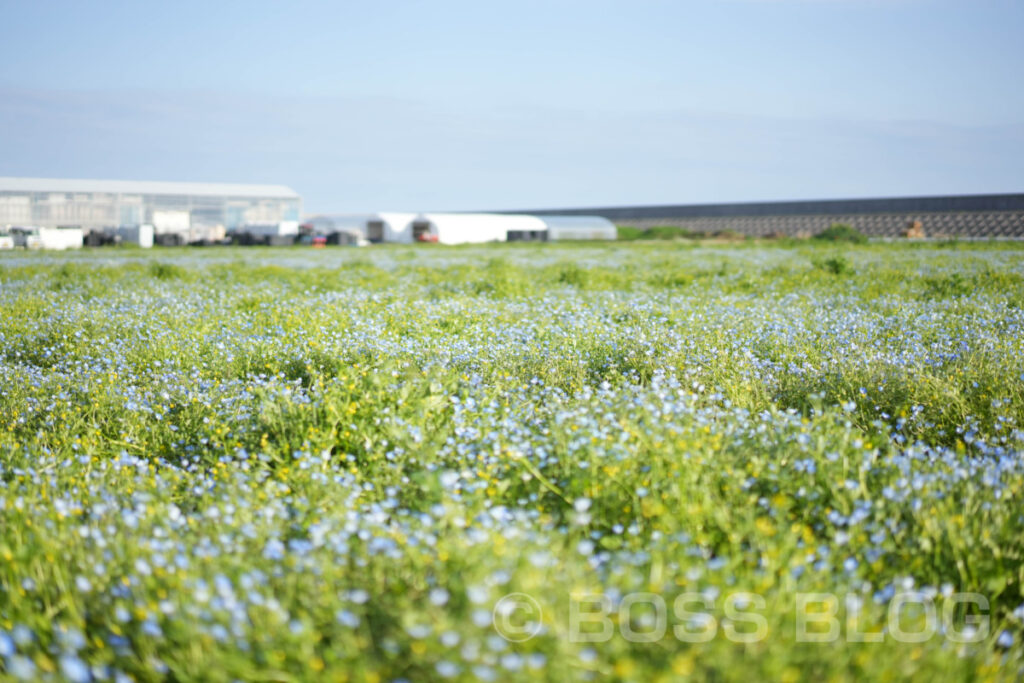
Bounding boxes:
[0,0,1024,212]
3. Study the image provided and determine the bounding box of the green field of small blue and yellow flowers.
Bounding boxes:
[0,244,1024,682]
